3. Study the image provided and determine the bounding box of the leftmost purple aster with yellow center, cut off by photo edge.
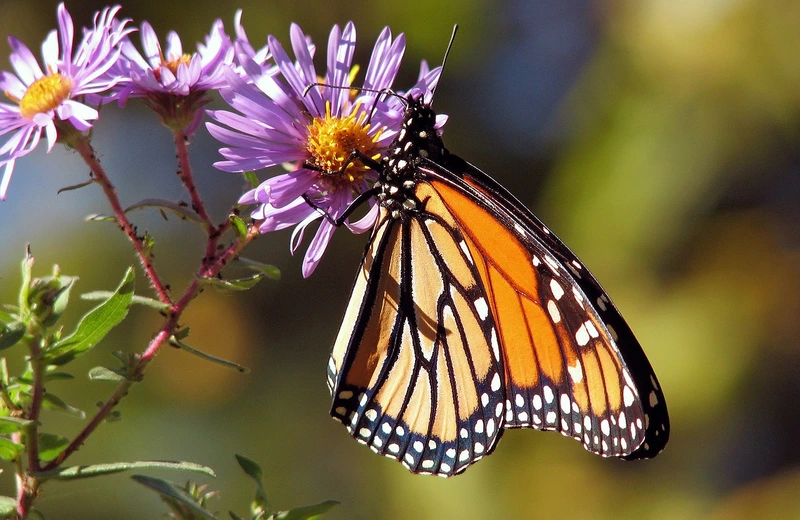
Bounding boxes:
[0,3,130,199]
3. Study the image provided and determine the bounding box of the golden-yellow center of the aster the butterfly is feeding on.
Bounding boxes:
[306,103,381,188]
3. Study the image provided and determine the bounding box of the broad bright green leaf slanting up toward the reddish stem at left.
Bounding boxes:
[43,267,134,365]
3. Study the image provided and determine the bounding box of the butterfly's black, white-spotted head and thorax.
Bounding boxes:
[378,96,448,218]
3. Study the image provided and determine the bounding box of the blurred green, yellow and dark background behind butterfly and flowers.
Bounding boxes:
[0,0,800,520]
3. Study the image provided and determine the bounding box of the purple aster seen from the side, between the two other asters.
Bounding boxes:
[114,16,234,135]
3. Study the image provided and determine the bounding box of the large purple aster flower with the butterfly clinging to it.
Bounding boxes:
[207,23,440,277]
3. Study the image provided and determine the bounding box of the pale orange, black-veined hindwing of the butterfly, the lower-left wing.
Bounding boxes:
[329,205,504,476]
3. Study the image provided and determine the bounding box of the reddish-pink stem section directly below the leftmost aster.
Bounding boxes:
[71,136,172,304]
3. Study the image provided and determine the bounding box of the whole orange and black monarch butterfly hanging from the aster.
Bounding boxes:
[328,61,669,477]
